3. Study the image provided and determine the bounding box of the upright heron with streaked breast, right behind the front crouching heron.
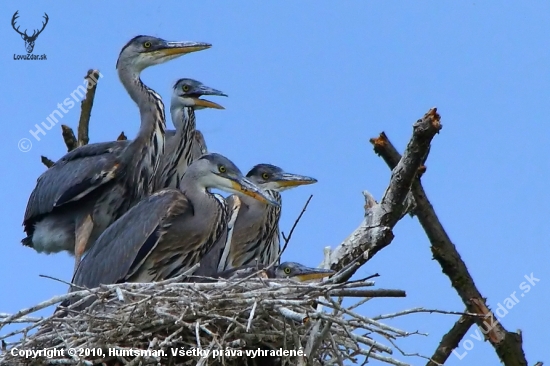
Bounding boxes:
[216,164,317,272]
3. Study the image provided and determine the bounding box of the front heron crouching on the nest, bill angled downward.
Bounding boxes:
[72,154,277,288]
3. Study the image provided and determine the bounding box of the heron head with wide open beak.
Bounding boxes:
[170,79,227,109]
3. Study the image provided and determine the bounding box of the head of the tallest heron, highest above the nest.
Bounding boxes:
[116,36,212,71]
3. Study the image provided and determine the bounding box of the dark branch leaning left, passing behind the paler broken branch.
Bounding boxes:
[371,133,527,366]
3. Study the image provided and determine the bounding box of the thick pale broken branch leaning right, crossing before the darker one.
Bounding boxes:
[330,108,441,281]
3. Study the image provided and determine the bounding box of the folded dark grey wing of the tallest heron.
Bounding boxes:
[23,141,126,230]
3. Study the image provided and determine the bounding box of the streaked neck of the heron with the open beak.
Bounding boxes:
[156,105,196,189]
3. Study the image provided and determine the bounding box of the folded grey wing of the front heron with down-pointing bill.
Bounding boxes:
[73,189,192,288]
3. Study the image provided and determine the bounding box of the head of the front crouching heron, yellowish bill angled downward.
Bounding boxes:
[194,153,279,206]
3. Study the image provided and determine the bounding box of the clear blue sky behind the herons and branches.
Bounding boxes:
[0,0,550,366]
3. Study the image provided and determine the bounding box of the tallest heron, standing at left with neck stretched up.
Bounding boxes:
[22,36,211,268]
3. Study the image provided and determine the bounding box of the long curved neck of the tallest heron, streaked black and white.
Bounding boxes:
[118,67,166,204]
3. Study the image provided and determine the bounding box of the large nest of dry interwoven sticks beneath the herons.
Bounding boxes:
[0,278,412,366]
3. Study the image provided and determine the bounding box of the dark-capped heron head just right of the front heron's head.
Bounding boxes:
[246,164,317,192]
